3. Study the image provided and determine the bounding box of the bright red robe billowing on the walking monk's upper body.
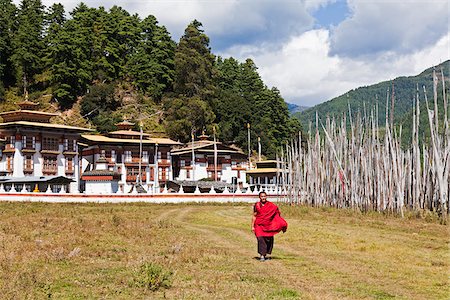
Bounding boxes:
[254,201,287,237]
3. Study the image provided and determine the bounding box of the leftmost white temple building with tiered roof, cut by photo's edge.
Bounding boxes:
[0,100,91,192]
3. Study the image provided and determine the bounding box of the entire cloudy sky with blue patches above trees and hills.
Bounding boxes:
[15,0,450,106]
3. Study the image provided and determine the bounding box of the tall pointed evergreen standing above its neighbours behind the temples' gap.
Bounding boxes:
[164,20,215,141]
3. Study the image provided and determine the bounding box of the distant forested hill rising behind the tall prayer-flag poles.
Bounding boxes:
[295,60,450,138]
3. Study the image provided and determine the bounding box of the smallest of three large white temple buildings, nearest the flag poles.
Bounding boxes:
[171,135,248,186]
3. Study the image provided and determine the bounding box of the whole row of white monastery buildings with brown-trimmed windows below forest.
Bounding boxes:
[0,100,279,194]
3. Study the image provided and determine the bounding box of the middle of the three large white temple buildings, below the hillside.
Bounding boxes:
[81,121,180,193]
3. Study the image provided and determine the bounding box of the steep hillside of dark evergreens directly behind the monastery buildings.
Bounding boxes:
[0,0,300,157]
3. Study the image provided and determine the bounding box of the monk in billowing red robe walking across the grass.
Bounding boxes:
[252,192,287,261]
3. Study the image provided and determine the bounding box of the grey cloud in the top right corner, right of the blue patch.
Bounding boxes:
[331,0,450,57]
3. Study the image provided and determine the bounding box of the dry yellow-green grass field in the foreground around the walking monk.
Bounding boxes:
[0,202,450,299]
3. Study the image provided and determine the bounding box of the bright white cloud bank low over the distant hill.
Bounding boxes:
[224,29,450,106]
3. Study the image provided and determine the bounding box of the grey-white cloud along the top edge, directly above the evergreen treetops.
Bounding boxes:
[32,0,312,49]
